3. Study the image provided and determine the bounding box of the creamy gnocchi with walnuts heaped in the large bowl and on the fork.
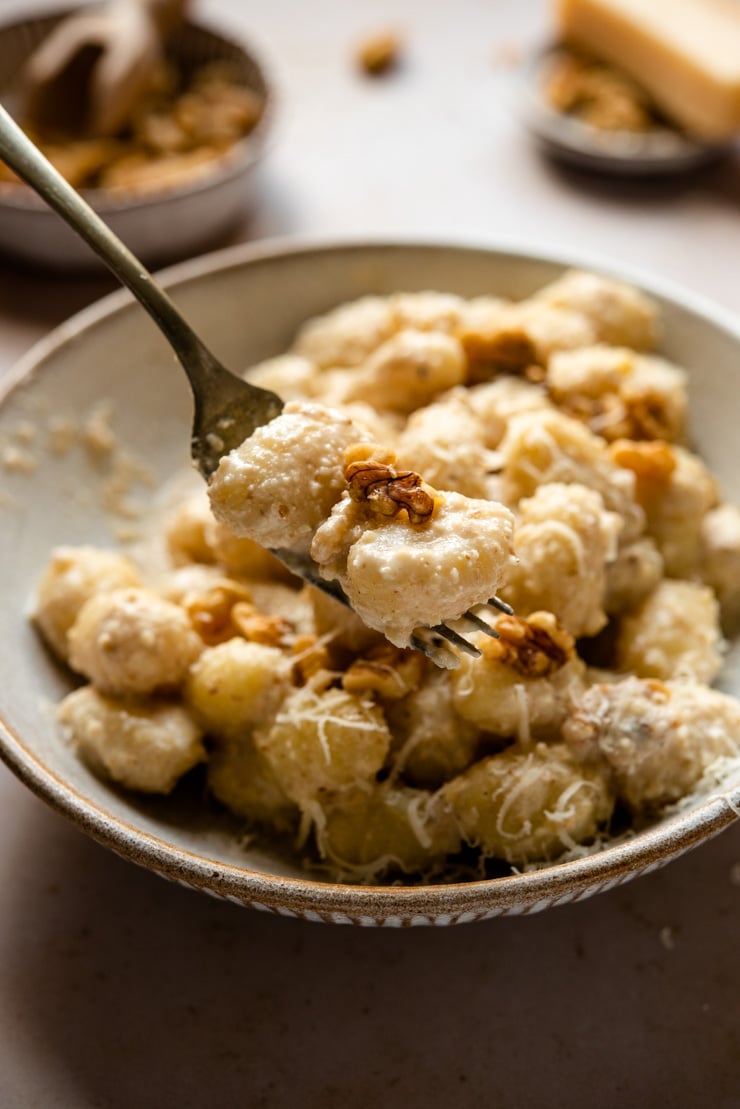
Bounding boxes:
[34,271,740,882]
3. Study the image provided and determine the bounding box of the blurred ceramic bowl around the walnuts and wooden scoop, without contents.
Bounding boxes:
[0,12,274,271]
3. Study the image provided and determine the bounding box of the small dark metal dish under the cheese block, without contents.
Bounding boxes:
[523,43,731,177]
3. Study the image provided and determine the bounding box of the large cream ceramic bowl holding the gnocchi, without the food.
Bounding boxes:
[0,236,740,925]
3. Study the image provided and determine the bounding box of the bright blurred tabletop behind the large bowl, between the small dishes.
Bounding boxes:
[0,0,740,368]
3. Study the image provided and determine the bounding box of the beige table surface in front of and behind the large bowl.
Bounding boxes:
[0,0,740,1109]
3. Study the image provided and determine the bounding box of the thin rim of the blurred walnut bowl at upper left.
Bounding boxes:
[0,6,276,216]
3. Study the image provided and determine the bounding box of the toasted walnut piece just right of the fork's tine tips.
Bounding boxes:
[480,612,576,678]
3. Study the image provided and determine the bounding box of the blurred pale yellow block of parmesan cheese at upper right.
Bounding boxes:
[556,0,740,140]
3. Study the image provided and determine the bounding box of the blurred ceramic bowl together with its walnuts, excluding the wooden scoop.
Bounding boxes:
[0,6,273,269]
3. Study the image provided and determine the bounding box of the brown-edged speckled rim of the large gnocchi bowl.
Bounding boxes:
[0,235,740,926]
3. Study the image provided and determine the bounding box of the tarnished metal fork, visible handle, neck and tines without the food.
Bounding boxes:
[0,105,513,669]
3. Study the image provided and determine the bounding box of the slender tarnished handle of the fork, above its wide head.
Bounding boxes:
[0,104,224,387]
